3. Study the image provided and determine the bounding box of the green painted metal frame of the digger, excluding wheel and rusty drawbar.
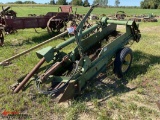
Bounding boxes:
[11,3,141,101]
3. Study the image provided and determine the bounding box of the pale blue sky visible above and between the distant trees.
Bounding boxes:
[0,0,143,6]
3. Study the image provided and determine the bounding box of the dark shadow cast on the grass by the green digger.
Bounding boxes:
[75,51,160,101]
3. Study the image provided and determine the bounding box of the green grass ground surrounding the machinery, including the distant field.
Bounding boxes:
[0,6,160,120]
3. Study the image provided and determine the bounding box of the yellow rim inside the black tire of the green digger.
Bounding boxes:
[122,54,131,73]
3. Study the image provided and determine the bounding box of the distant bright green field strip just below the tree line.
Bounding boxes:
[1,4,160,16]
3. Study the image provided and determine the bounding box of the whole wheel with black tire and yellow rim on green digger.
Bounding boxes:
[114,47,132,78]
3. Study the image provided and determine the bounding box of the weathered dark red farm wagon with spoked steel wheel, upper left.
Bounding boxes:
[0,5,76,45]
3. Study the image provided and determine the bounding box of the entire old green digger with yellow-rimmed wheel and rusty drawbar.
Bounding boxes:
[11,5,141,102]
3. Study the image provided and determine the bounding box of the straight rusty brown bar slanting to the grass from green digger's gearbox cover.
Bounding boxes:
[13,58,45,93]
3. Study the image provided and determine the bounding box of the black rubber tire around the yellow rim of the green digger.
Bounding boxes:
[113,47,133,78]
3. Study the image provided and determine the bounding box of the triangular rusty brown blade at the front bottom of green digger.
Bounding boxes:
[58,80,75,103]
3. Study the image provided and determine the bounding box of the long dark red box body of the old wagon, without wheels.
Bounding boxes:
[0,11,70,33]
